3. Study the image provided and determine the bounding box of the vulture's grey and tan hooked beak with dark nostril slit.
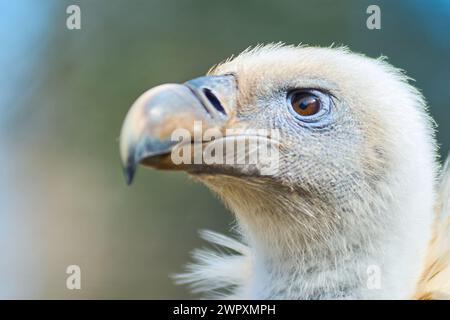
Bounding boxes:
[120,75,237,184]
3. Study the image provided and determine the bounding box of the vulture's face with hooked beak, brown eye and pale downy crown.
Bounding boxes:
[121,45,430,234]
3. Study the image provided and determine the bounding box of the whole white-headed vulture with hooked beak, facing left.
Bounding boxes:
[120,44,450,300]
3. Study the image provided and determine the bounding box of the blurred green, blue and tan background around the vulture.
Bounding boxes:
[0,0,450,299]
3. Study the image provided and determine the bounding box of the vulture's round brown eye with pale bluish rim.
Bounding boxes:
[287,89,332,122]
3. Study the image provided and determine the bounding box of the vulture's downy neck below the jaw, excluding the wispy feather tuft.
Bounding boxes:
[207,172,433,299]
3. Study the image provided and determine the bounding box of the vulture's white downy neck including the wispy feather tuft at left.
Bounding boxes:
[178,151,434,299]
